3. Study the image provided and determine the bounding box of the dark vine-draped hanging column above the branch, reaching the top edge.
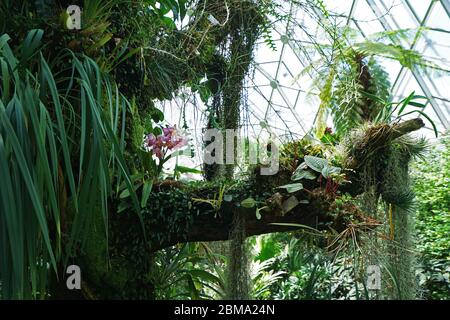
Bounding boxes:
[198,0,265,180]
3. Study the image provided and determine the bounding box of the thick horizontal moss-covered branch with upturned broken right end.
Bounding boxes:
[115,119,424,251]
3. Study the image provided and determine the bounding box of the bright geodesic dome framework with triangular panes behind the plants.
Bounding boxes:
[160,0,450,165]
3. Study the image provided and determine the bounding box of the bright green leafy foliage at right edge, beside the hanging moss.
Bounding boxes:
[413,135,450,299]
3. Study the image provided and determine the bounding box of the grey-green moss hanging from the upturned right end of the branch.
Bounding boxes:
[345,124,425,299]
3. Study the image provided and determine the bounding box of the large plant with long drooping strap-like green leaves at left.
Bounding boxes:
[0,30,138,299]
